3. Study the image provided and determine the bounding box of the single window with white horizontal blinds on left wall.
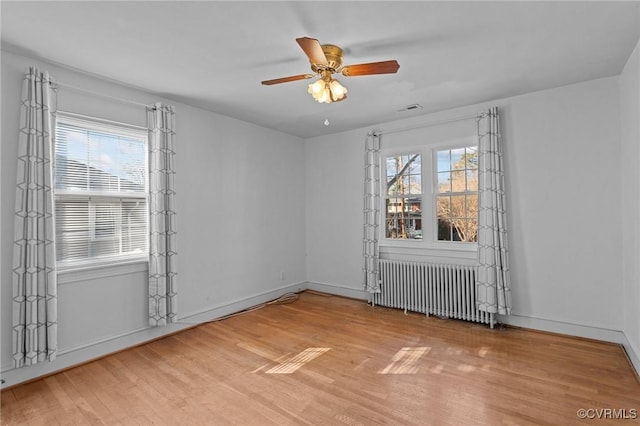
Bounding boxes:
[54,112,148,266]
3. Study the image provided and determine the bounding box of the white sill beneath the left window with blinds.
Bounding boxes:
[58,258,149,284]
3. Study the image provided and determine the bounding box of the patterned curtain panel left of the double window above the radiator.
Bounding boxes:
[363,133,380,293]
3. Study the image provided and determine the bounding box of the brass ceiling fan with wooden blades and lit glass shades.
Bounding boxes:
[262,37,400,103]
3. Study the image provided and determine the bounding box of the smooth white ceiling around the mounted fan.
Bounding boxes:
[0,1,640,137]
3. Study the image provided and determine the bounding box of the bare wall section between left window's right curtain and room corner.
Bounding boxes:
[171,100,306,317]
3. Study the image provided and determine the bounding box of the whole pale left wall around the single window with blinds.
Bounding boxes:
[0,51,306,386]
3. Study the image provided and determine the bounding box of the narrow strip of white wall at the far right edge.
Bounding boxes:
[620,42,640,371]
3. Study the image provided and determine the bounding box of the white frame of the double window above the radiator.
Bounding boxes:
[378,136,478,257]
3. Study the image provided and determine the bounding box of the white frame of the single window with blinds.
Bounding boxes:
[53,111,150,276]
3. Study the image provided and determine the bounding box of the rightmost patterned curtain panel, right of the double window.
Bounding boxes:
[476,107,511,315]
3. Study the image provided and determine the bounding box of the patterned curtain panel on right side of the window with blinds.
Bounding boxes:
[147,103,178,326]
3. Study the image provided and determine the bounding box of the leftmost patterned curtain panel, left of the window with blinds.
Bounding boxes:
[12,67,58,368]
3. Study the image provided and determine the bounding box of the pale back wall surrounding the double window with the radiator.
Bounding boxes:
[306,78,623,340]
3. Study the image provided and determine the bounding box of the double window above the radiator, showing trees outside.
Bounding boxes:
[381,139,478,247]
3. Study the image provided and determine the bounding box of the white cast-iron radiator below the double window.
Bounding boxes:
[372,259,495,328]
